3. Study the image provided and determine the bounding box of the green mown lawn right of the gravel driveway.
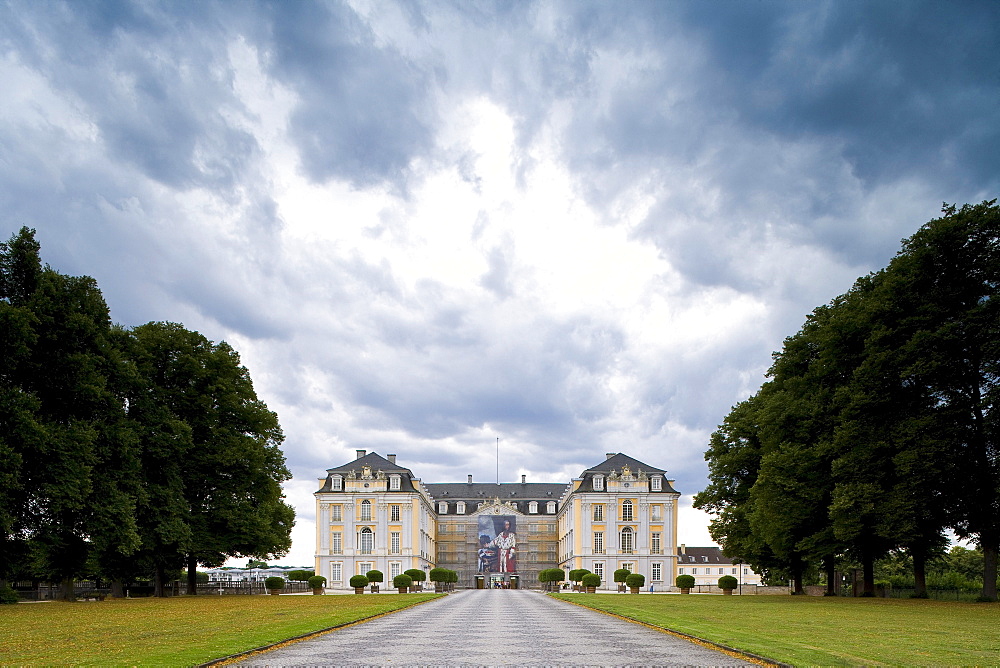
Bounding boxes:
[554,594,1000,666]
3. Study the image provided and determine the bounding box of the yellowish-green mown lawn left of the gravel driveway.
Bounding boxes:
[0,594,441,666]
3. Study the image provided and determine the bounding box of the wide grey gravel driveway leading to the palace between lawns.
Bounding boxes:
[230,589,752,666]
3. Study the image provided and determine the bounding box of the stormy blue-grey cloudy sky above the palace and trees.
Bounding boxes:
[0,0,1000,565]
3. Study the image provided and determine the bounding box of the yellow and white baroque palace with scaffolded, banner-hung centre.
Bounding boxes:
[315,450,680,590]
